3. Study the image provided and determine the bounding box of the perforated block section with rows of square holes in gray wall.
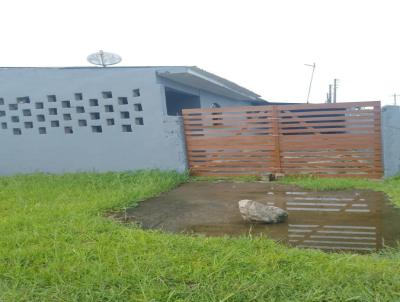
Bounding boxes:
[0,88,144,135]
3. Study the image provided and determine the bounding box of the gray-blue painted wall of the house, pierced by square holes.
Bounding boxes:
[0,68,253,175]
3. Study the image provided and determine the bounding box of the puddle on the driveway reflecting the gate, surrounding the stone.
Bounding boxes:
[121,182,400,253]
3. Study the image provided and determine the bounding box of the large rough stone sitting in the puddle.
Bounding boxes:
[239,199,288,223]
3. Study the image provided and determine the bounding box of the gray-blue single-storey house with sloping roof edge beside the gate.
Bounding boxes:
[0,66,266,175]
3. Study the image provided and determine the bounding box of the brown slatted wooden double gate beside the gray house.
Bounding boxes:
[183,102,382,178]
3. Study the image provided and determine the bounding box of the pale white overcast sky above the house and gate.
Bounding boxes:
[0,0,400,104]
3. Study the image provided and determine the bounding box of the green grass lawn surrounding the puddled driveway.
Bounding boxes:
[0,171,400,302]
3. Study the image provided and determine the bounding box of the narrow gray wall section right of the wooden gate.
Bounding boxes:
[382,106,400,177]
